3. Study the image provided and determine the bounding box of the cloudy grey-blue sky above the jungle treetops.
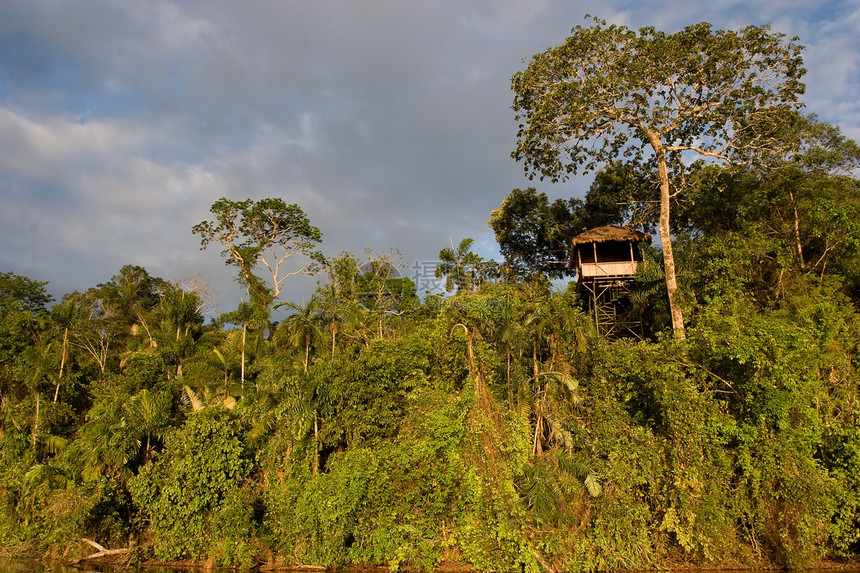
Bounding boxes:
[0,0,860,312]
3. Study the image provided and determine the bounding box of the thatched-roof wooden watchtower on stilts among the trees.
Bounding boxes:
[570,225,651,338]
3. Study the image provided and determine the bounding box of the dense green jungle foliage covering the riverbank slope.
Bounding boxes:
[0,135,860,571]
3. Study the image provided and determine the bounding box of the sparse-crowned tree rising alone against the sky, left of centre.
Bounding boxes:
[191,197,323,309]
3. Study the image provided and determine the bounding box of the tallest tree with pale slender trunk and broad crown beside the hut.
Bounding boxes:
[512,19,805,339]
